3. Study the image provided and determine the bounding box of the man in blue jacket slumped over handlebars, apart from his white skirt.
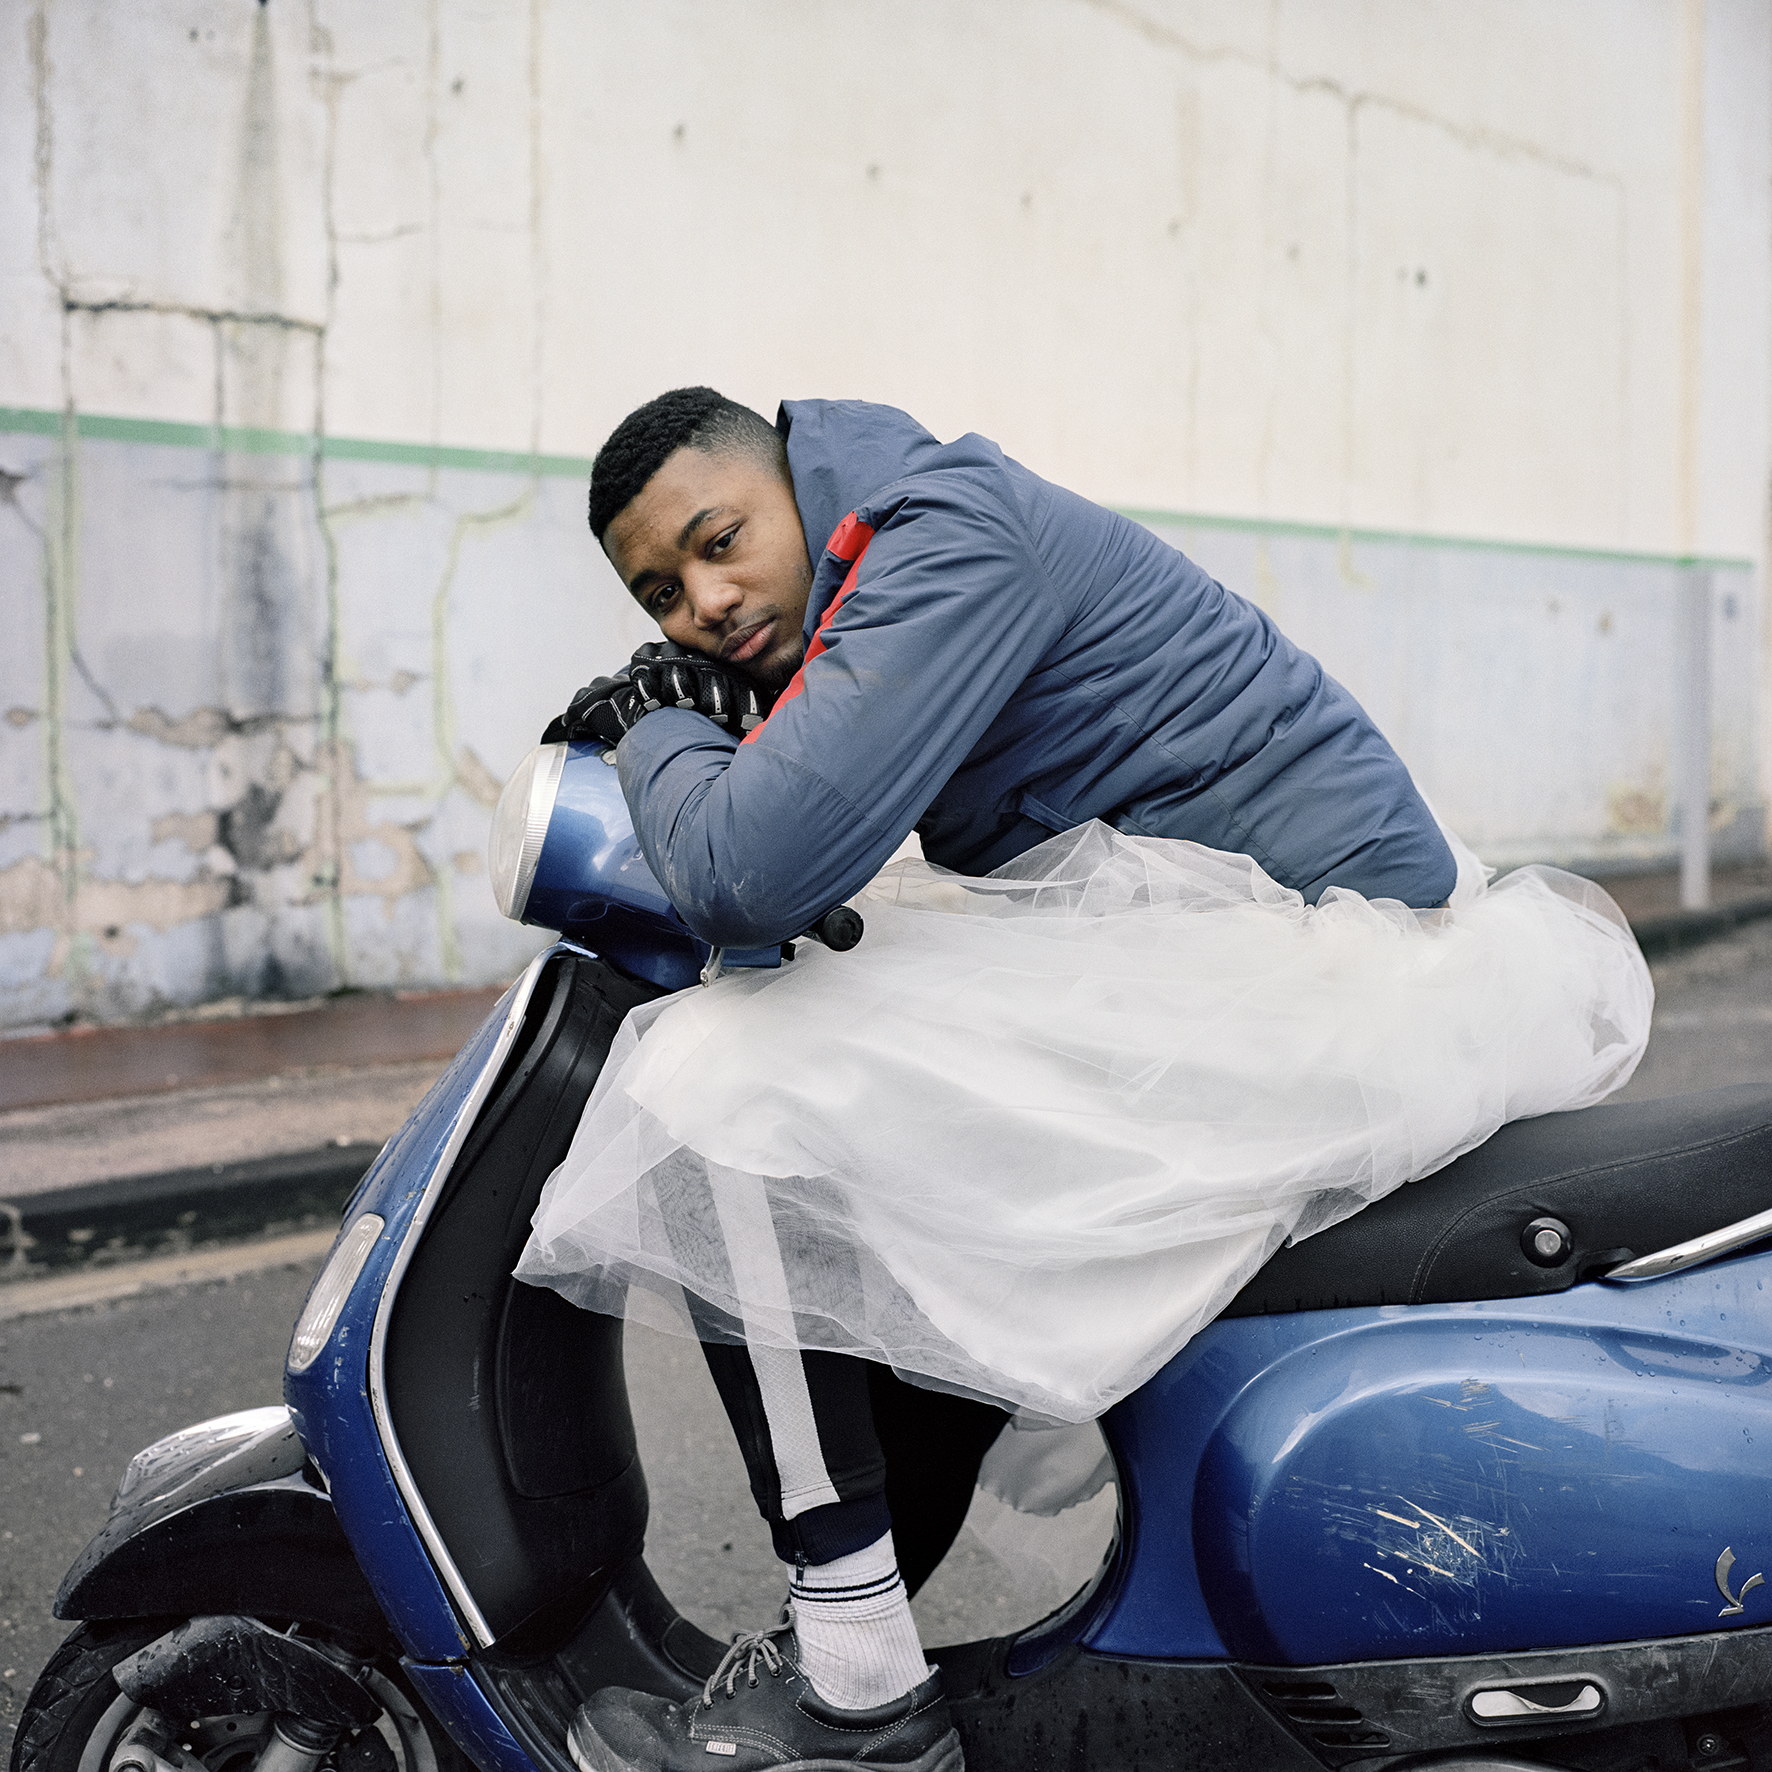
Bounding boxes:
[549,388,1457,1772]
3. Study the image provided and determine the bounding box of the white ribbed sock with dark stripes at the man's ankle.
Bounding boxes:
[789,1533,929,1710]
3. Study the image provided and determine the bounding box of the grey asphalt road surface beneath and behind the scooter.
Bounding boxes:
[0,921,1772,1745]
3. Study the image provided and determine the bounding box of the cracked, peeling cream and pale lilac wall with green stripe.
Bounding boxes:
[0,0,1772,1026]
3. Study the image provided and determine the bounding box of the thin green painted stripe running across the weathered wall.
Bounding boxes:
[0,406,1753,571]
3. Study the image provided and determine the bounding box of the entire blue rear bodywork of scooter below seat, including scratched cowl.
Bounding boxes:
[1088,1253,1772,1666]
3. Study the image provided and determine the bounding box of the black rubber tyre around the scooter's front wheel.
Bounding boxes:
[11,1618,471,1772]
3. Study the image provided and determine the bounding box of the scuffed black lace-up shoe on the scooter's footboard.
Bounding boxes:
[567,1623,964,1772]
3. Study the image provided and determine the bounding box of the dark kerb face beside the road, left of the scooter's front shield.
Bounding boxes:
[0,1141,381,1283]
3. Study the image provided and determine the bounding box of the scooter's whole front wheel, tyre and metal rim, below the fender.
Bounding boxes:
[12,1618,466,1772]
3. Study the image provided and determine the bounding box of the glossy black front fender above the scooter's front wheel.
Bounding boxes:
[55,1405,393,1648]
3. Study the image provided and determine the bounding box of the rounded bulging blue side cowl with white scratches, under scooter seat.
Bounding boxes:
[1194,1288,1772,1666]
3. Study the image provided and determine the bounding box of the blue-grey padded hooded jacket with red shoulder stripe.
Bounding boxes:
[617,400,1457,948]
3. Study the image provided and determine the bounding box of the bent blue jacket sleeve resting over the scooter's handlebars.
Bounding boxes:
[617,477,1065,948]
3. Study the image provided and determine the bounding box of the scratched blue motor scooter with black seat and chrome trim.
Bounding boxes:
[12,744,1772,1772]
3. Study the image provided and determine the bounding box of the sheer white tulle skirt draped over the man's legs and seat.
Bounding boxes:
[517,824,1653,1421]
